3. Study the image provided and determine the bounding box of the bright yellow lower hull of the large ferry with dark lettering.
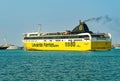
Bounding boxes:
[23,41,111,51]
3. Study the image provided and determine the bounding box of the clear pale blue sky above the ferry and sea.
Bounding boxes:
[0,0,120,46]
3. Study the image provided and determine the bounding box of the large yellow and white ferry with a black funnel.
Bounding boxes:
[23,21,111,51]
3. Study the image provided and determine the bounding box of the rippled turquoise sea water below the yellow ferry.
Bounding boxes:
[0,49,120,81]
